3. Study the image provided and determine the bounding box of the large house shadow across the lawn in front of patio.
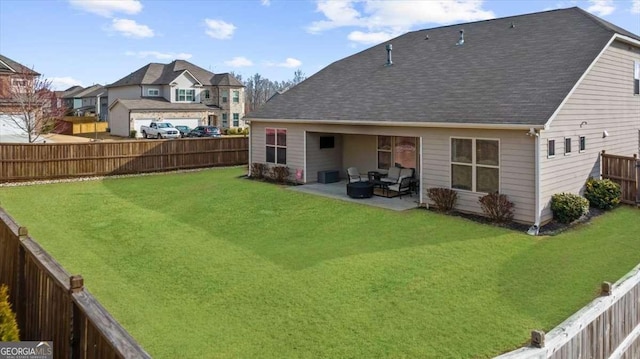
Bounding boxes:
[104,169,506,269]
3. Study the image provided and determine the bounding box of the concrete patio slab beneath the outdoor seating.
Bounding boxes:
[288,180,419,211]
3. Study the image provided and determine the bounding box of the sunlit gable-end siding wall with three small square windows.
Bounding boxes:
[540,42,640,222]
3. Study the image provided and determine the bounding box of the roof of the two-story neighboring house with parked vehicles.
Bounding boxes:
[107,60,242,87]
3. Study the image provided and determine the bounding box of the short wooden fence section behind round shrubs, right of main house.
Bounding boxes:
[600,151,640,204]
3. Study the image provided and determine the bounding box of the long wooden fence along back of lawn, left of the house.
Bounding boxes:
[0,138,249,183]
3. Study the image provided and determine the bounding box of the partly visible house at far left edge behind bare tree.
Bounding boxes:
[0,55,40,141]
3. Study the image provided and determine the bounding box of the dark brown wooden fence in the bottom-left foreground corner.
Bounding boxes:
[0,208,151,359]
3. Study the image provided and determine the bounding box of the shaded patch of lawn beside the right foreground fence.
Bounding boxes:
[500,207,640,331]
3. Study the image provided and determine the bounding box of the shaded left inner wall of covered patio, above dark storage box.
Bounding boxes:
[306,132,344,182]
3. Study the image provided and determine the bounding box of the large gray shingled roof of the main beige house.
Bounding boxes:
[246,8,639,125]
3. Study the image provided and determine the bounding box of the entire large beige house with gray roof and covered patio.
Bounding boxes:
[247,7,640,229]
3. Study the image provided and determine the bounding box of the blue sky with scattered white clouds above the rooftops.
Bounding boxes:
[0,0,640,90]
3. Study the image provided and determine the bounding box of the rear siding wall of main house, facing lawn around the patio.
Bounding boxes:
[251,120,535,223]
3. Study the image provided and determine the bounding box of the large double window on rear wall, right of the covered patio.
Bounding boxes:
[451,138,500,193]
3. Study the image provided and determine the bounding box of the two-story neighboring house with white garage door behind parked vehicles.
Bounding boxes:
[107,60,245,136]
